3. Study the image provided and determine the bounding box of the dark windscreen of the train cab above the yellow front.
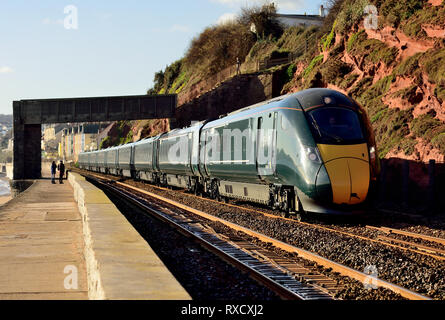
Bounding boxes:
[308,107,365,144]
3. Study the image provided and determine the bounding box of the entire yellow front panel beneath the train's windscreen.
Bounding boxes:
[318,143,370,205]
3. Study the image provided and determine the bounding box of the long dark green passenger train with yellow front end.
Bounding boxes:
[78,88,380,219]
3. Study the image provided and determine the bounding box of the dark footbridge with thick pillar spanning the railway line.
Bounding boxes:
[13,94,177,180]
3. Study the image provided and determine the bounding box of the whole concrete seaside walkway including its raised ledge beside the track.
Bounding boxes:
[0,163,191,300]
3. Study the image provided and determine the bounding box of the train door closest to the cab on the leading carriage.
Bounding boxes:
[256,112,278,182]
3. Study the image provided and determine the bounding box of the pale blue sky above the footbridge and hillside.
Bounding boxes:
[0,0,324,114]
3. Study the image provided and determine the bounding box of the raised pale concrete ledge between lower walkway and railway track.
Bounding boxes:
[68,173,191,300]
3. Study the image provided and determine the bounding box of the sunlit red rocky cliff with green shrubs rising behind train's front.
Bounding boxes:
[283,0,445,163]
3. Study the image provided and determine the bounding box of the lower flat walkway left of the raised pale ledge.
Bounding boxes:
[0,180,88,300]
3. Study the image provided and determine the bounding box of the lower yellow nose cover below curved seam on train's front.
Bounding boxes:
[325,158,370,204]
